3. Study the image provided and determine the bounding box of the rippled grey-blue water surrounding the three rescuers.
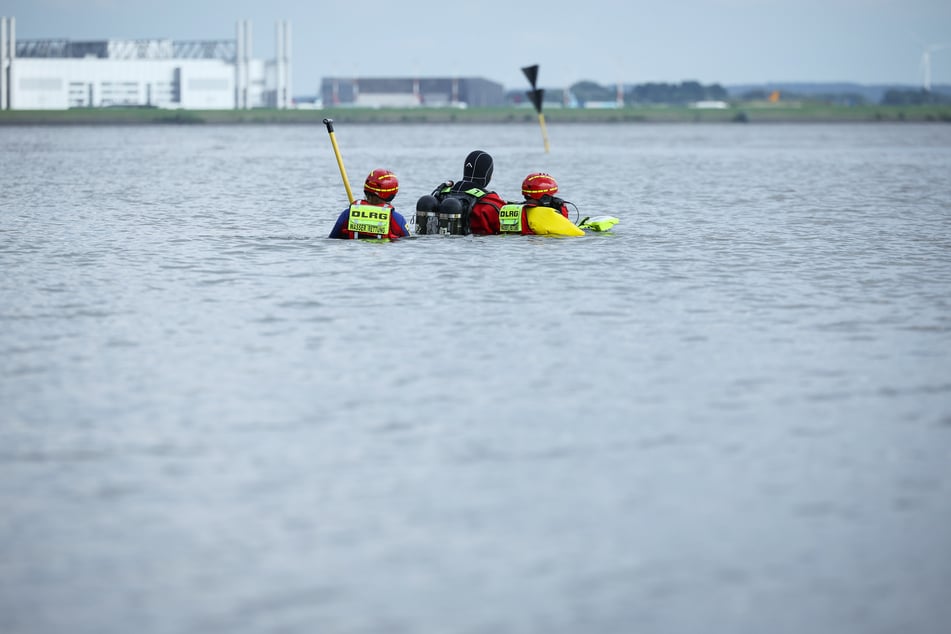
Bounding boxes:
[0,124,951,634]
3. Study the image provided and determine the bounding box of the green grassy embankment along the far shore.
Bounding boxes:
[0,103,951,125]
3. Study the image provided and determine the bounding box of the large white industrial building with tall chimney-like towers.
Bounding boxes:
[0,18,291,110]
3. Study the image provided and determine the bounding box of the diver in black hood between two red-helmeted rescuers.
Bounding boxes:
[432,150,505,235]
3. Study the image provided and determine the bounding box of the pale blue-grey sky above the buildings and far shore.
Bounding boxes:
[0,0,951,95]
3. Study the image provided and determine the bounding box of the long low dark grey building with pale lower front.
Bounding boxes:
[320,77,505,108]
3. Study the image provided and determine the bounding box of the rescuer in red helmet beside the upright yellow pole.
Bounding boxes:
[327,168,409,240]
